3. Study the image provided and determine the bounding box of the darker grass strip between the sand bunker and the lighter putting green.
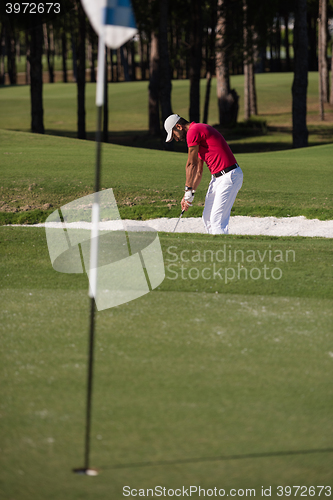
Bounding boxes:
[0,227,333,299]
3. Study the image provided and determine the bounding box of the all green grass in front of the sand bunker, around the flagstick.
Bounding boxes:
[0,227,333,500]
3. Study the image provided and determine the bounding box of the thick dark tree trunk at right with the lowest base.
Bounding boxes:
[292,0,308,148]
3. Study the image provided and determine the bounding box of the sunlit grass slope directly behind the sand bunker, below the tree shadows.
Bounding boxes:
[0,131,333,224]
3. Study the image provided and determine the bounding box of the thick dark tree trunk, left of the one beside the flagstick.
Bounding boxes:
[29,25,44,134]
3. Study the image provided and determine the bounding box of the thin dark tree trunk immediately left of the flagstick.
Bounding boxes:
[77,3,86,139]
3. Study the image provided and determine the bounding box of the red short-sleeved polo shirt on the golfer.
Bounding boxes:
[186,122,236,174]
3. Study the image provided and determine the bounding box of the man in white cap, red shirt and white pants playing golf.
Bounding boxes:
[164,115,243,234]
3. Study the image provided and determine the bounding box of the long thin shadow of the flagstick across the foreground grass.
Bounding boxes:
[101,448,333,470]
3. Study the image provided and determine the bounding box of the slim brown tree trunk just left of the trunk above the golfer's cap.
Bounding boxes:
[149,31,161,136]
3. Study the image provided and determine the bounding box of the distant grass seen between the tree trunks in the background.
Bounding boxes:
[0,72,333,153]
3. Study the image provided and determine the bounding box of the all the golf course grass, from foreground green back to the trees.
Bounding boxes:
[0,74,333,500]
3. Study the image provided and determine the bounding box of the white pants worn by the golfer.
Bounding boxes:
[202,167,243,234]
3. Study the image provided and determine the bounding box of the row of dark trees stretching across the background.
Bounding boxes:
[0,0,333,147]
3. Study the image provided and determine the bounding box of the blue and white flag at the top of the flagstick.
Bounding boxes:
[81,0,137,49]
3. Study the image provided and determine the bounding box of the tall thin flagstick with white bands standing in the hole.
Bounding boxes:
[74,32,105,476]
